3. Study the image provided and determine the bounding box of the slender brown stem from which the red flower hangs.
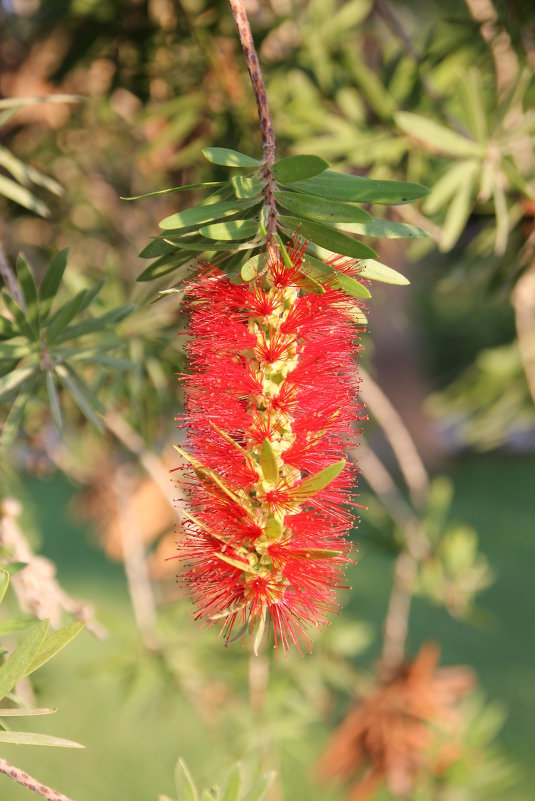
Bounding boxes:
[229,0,277,249]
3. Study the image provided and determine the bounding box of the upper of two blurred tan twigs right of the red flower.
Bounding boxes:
[360,367,429,508]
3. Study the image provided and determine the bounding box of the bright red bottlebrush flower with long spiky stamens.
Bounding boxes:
[177,246,361,654]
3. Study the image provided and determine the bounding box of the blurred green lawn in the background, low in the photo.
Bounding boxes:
[0,456,535,801]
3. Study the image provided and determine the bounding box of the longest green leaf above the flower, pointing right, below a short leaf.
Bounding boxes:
[284,170,429,205]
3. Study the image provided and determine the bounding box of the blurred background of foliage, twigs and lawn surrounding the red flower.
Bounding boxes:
[0,0,535,801]
